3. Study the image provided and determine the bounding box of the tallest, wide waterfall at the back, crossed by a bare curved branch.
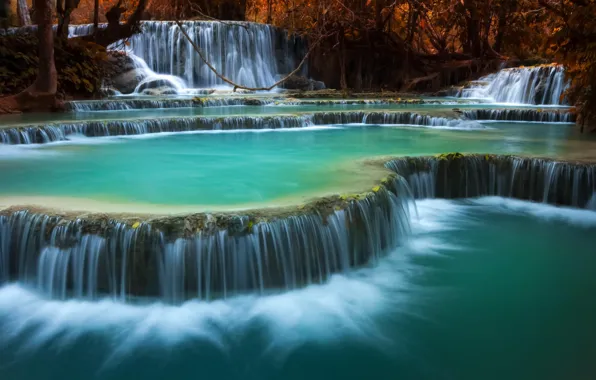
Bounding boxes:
[70,21,304,88]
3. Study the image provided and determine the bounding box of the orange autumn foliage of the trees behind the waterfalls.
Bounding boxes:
[4,0,596,124]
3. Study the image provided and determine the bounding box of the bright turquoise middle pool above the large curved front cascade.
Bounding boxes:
[0,123,572,205]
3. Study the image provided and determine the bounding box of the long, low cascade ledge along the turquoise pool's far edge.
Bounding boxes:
[0,112,474,145]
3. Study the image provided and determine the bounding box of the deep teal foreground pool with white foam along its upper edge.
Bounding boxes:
[0,198,596,380]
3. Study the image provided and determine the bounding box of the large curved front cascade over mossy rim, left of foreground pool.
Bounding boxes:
[0,180,410,303]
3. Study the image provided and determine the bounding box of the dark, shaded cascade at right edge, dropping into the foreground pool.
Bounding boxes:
[386,154,596,208]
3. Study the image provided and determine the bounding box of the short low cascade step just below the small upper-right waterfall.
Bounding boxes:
[463,109,575,123]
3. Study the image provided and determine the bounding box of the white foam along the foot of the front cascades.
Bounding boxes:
[0,197,596,367]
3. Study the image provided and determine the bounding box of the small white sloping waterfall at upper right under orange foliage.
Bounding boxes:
[458,65,568,105]
